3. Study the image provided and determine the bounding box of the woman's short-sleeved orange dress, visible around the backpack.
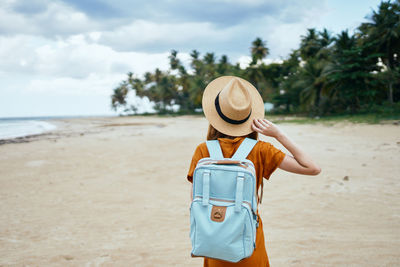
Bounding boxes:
[187,137,285,267]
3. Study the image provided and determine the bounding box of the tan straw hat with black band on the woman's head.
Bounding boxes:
[202,76,264,136]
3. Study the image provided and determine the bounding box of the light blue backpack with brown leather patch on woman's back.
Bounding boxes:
[190,138,258,262]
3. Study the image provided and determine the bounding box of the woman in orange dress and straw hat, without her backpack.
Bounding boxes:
[187,76,321,267]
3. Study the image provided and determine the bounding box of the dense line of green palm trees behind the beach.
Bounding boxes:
[111,0,400,116]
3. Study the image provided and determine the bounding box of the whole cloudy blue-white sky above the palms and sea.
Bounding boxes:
[0,0,380,117]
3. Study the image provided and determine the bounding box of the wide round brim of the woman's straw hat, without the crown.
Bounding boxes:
[202,76,265,136]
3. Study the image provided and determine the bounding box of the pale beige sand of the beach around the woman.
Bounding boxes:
[0,116,400,266]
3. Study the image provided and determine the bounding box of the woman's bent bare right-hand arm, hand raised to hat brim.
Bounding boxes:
[252,119,321,175]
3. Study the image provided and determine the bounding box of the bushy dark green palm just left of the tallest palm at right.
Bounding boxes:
[322,31,379,113]
